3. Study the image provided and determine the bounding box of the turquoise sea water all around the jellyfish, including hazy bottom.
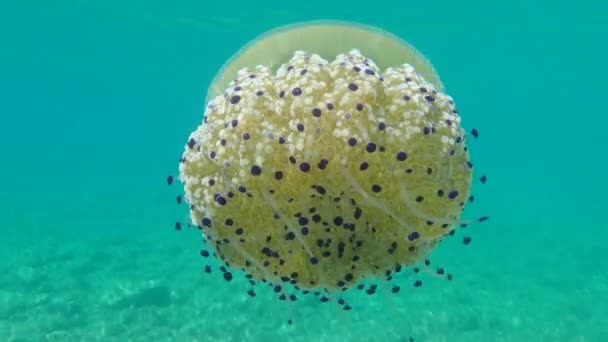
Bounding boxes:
[0,0,608,342]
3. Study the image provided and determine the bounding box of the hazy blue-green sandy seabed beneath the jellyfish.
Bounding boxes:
[0,200,608,342]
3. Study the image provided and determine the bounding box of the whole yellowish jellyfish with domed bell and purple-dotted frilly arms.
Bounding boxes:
[180,22,471,289]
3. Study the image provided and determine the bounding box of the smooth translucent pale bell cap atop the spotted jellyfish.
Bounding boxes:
[206,21,443,102]
